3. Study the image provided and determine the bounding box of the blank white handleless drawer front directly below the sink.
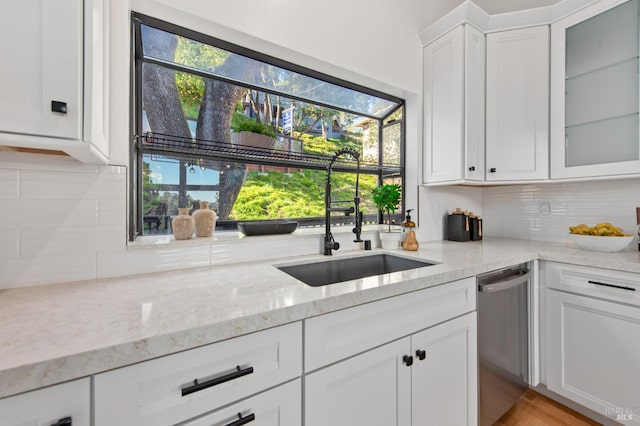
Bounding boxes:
[305,277,476,371]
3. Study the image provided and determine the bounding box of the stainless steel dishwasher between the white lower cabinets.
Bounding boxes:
[478,264,529,426]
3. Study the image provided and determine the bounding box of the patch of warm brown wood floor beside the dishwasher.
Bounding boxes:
[495,390,600,426]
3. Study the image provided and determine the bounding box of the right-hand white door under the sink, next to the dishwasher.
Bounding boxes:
[411,312,478,426]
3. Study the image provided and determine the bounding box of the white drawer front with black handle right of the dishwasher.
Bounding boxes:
[545,262,640,306]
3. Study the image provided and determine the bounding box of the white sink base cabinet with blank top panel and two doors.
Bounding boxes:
[304,278,478,426]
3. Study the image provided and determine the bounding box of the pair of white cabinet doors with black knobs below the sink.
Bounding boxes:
[305,312,478,426]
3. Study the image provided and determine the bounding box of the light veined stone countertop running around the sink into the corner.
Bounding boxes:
[0,238,640,397]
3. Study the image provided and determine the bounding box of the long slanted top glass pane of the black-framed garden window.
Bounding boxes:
[141,25,398,117]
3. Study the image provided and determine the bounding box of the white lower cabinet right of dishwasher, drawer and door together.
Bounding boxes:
[545,264,640,424]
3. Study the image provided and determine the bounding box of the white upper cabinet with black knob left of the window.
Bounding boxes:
[0,0,108,161]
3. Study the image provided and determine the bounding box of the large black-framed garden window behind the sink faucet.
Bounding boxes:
[130,14,404,239]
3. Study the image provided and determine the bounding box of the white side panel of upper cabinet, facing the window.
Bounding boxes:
[423,26,464,183]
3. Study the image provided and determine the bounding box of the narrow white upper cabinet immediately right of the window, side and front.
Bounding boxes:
[423,25,485,184]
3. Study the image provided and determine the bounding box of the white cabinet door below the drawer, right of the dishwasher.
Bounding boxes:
[546,290,640,424]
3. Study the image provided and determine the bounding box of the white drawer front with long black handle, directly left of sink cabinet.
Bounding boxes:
[95,322,302,426]
